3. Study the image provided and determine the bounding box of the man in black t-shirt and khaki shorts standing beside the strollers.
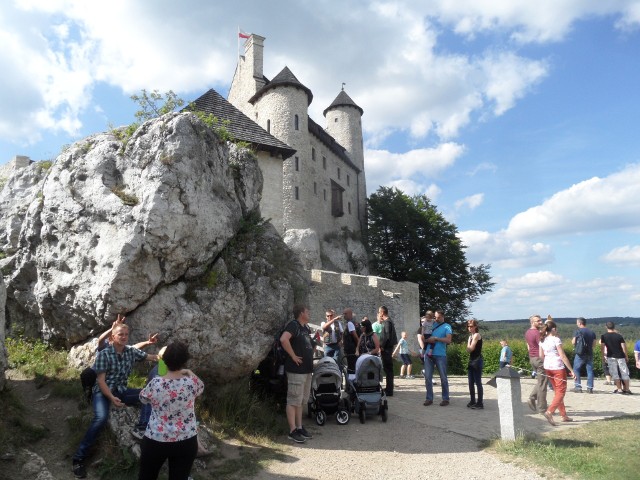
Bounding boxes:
[280,305,313,443]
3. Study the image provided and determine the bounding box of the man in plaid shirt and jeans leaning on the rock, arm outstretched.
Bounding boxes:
[73,323,158,478]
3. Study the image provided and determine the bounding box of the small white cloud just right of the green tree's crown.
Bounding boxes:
[458,230,554,269]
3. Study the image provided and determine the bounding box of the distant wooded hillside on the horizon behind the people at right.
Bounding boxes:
[480,317,640,347]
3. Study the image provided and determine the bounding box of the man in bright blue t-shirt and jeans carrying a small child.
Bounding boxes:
[423,310,453,407]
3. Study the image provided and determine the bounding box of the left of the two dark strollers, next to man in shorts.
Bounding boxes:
[307,357,350,425]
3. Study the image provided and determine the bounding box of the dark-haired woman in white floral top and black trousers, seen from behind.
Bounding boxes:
[138,342,204,480]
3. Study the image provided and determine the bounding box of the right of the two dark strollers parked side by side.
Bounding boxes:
[347,355,389,423]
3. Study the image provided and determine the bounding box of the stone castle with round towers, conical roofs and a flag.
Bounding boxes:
[193,34,367,273]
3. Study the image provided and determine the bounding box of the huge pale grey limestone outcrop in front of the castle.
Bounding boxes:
[0,113,305,380]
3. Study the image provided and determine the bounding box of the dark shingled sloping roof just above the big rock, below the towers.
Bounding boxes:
[185,89,296,159]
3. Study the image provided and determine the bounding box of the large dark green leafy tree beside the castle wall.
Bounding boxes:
[367,187,494,340]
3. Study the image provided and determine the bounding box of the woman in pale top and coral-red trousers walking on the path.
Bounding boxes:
[540,320,573,426]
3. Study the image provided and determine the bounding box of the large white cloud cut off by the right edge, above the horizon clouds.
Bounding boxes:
[506,164,640,238]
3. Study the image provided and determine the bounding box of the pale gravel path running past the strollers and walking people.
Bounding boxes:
[254,377,640,480]
